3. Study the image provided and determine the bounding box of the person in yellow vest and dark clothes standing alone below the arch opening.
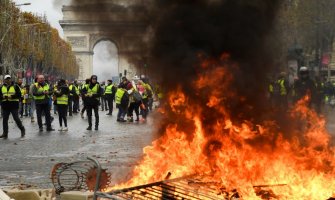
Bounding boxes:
[82,75,102,130]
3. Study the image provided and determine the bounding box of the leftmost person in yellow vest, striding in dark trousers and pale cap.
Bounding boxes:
[0,75,26,139]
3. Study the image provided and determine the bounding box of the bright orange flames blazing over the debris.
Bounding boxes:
[113,54,335,200]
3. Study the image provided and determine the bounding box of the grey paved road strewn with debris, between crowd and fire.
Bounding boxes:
[0,111,153,188]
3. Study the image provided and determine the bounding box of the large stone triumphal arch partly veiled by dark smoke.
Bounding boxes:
[60,0,147,80]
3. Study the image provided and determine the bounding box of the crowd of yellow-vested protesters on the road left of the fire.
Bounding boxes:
[0,75,163,139]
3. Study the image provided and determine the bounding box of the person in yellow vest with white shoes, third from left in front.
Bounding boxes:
[54,79,70,131]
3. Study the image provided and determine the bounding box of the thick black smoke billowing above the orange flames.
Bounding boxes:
[72,0,286,128]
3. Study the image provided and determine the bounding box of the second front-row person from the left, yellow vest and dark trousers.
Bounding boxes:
[33,75,55,131]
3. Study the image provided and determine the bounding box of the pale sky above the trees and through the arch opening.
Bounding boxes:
[14,0,118,82]
